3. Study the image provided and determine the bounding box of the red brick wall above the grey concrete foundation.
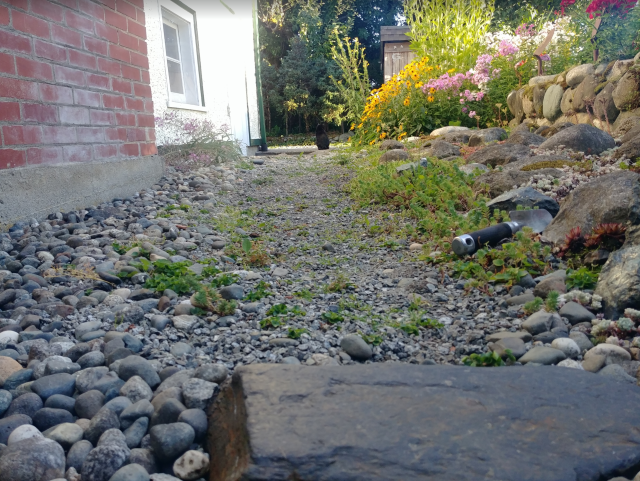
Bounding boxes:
[0,0,156,169]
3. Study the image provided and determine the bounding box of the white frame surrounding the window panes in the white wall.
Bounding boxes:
[158,0,202,112]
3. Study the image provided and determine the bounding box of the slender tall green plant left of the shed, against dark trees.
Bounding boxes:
[331,31,371,122]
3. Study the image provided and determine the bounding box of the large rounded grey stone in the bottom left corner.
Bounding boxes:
[0,436,65,481]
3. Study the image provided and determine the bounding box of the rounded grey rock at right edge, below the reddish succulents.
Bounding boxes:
[596,246,640,318]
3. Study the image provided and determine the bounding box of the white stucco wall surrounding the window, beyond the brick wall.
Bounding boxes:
[144,0,260,150]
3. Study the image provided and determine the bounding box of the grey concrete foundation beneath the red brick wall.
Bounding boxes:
[0,155,164,227]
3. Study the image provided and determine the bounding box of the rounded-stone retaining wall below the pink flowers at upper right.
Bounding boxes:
[507,54,640,133]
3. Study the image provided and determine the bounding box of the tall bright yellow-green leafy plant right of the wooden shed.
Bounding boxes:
[404,0,495,72]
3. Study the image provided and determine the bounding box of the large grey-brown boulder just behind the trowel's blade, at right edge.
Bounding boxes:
[543,171,640,243]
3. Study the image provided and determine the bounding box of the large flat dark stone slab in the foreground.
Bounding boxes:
[209,364,640,481]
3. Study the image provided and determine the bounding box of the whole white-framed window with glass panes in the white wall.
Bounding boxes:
[160,0,202,107]
